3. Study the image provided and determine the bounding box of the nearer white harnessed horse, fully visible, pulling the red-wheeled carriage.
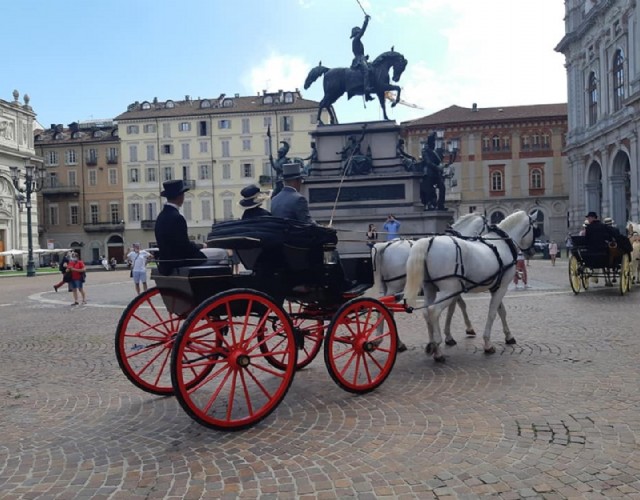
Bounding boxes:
[404,210,537,361]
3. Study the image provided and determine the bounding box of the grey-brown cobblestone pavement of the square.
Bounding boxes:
[0,259,640,499]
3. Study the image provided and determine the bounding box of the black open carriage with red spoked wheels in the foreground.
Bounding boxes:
[115,217,404,430]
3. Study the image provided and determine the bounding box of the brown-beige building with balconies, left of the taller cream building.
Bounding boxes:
[35,120,124,263]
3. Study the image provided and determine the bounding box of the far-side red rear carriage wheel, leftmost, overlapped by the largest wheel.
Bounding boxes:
[115,287,204,396]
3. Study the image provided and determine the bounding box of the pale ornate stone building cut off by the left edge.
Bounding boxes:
[0,90,41,269]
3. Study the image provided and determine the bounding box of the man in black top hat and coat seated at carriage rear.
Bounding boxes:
[155,179,207,275]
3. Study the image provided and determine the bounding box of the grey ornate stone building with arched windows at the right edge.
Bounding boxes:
[556,0,640,229]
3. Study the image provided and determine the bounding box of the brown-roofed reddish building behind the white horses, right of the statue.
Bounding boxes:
[402,104,569,242]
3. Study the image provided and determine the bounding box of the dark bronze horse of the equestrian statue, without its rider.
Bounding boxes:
[304,50,407,124]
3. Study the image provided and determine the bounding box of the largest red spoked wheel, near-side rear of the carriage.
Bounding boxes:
[171,289,298,430]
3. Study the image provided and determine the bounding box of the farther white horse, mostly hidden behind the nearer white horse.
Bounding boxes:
[371,213,490,352]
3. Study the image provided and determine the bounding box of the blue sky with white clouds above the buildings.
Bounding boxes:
[0,0,567,127]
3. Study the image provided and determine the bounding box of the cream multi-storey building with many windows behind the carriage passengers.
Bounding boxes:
[116,90,318,250]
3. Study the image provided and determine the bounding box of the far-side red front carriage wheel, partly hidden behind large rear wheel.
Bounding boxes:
[260,301,324,370]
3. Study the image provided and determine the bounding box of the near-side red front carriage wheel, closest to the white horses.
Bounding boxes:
[324,297,398,393]
